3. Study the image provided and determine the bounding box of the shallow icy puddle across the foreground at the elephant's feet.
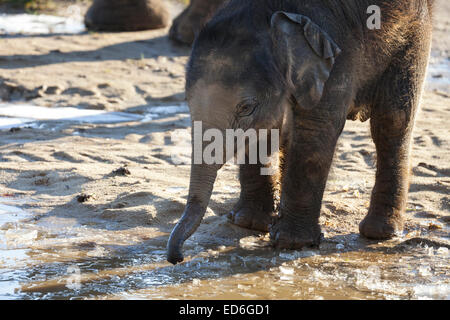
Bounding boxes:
[0,199,450,299]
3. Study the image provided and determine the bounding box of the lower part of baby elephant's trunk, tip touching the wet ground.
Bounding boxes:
[167,164,220,264]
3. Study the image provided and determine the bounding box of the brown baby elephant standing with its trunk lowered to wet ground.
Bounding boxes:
[168,0,433,264]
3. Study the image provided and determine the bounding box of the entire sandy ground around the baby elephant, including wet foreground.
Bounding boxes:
[0,1,450,299]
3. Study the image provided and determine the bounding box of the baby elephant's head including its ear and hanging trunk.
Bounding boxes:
[168,7,340,264]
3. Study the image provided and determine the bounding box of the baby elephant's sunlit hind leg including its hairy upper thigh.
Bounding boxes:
[359,37,429,239]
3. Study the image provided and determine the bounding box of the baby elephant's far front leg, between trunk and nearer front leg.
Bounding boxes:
[228,164,278,232]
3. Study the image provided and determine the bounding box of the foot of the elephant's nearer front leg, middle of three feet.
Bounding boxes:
[270,219,323,250]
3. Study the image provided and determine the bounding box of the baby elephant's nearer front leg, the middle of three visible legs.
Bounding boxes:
[270,119,344,249]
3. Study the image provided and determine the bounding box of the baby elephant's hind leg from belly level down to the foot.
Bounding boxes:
[359,106,411,240]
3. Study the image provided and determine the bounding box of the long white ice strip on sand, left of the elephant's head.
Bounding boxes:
[0,103,143,129]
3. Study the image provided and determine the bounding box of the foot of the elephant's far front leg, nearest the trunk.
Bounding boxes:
[227,202,275,232]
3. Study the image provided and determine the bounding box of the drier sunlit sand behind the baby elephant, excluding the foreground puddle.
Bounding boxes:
[0,0,450,300]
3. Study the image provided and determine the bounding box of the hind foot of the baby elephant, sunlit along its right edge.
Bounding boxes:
[359,209,404,240]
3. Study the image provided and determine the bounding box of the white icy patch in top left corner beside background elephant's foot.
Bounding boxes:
[0,14,86,34]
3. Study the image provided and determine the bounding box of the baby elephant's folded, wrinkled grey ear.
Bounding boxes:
[271,11,341,109]
